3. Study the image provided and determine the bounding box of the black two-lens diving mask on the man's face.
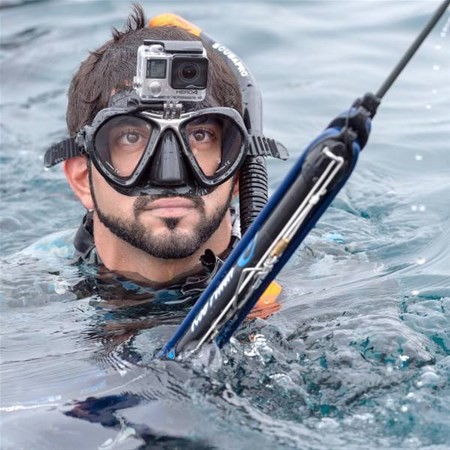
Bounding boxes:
[45,93,248,196]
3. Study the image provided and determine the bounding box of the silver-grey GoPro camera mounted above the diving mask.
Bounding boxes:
[133,40,208,102]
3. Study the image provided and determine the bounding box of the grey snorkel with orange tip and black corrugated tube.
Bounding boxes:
[149,13,288,234]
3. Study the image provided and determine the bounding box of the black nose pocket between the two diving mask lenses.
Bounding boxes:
[149,130,189,186]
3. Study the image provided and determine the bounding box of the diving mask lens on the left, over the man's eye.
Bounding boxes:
[94,115,154,178]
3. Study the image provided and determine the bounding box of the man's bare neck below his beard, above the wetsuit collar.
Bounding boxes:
[94,212,232,283]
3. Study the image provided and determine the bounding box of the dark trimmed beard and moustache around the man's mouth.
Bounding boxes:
[90,175,233,259]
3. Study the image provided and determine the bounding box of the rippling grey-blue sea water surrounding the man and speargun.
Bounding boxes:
[0,0,450,449]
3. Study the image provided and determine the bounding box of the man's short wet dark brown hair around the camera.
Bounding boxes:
[66,3,242,136]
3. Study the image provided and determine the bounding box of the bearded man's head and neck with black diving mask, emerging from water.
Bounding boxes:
[46,6,282,292]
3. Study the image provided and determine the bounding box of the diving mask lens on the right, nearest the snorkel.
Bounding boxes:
[180,113,245,178]
